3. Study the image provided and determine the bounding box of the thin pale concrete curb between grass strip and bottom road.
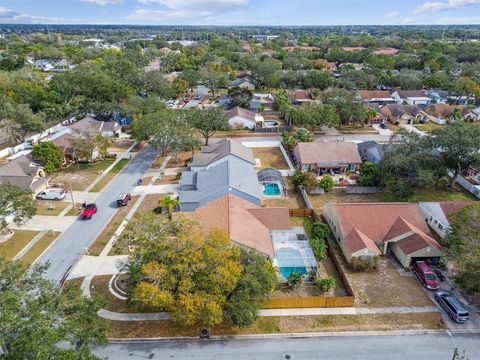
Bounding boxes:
[108,329,480,343]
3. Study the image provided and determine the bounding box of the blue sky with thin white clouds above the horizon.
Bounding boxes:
[0,0,480,25]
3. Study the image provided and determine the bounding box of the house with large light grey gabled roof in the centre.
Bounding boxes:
[179,139,262,211]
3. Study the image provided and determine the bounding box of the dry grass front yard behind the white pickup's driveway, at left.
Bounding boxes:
[50,159,113,191]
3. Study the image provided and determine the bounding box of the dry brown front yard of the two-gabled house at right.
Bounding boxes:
[331,240,433,307]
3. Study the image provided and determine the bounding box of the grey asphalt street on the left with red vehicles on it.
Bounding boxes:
[38,145,156,284]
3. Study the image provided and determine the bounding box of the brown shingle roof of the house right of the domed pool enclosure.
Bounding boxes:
[293,142,362,164]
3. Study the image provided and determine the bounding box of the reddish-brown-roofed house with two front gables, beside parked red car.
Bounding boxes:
[323,203,443,268]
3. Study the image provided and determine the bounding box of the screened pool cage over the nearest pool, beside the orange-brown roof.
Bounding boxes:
[271,227,318,280]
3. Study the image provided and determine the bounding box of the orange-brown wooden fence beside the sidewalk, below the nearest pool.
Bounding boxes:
[263,296,355,309]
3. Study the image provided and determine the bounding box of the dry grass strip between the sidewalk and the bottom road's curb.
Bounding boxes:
[108,312,445,338]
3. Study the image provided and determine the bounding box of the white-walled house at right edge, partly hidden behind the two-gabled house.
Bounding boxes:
[418,201,476,238]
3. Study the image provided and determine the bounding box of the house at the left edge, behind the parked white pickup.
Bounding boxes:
[0,154,48,195]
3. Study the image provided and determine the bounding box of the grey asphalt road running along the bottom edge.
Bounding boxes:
[93,333,480,360]
